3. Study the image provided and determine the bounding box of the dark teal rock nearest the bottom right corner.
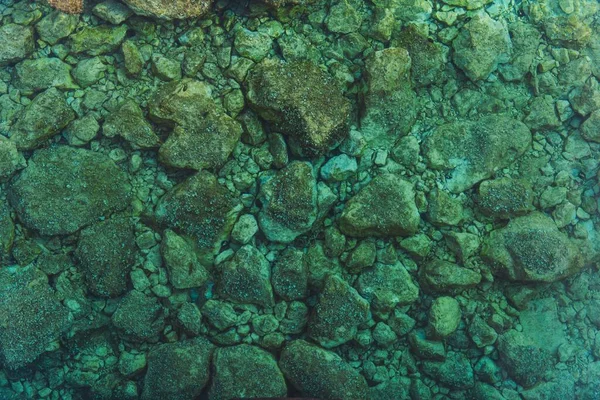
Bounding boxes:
[497,329,554,387]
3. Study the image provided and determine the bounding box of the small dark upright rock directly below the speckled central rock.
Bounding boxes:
[271,248,308,301]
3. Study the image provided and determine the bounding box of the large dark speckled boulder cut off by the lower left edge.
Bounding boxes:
[0,266,72,369]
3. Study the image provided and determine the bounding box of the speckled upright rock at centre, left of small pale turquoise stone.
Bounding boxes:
[258,161,318,243]
